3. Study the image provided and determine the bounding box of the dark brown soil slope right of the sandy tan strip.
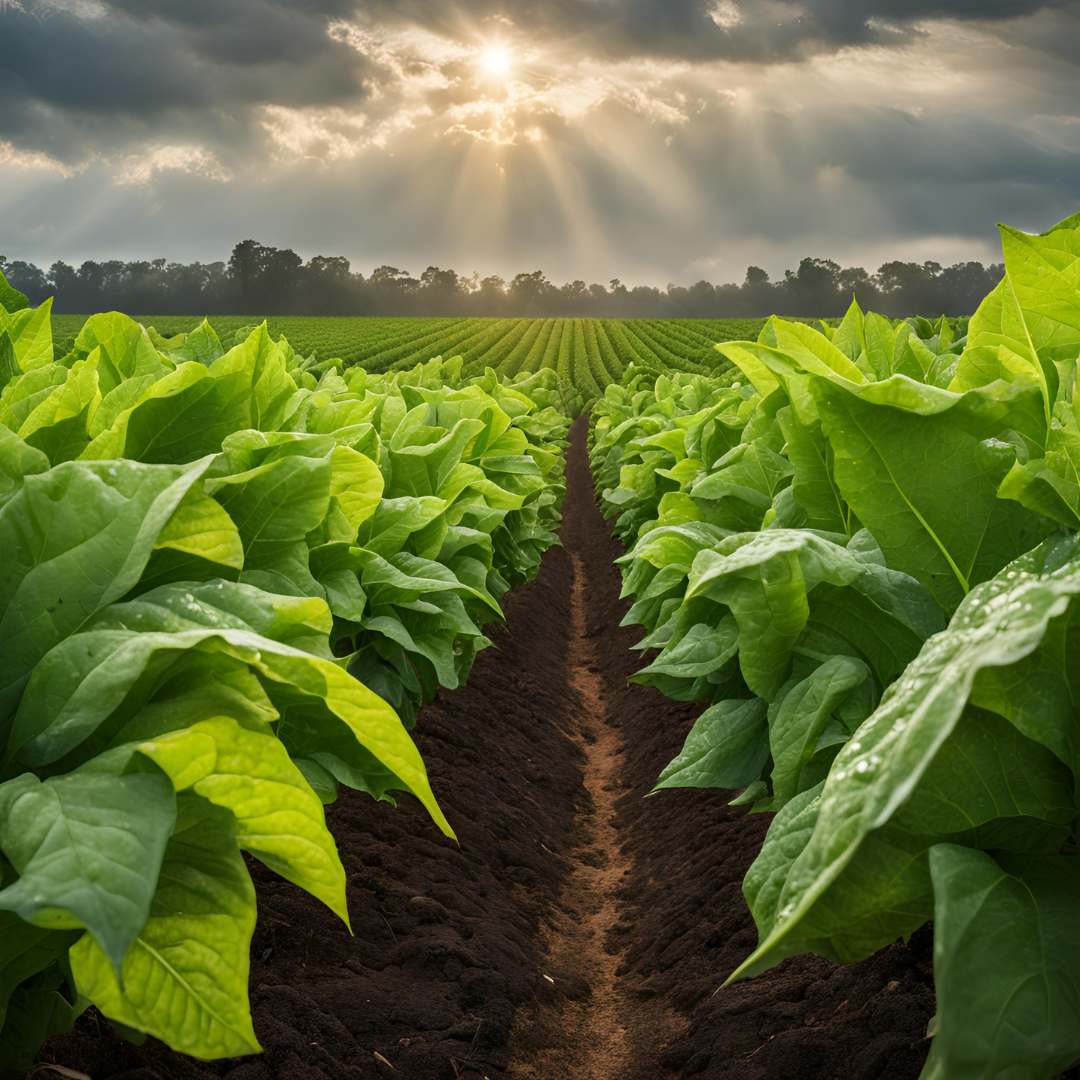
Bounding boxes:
[552,414,934,1080]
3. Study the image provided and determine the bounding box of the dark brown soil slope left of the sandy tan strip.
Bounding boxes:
[41,524,583,1080]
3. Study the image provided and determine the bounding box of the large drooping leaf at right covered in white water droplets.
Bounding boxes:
[737,539,1080,977]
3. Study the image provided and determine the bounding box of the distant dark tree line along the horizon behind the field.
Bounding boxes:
[0,240,1004,319]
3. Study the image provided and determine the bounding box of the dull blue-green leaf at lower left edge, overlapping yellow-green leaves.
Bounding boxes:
[0,772,176,971]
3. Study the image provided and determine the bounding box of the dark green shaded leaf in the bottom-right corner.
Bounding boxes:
[923,845,1080,1080]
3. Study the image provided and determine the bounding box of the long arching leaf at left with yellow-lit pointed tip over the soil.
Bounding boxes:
[11,582,453,835]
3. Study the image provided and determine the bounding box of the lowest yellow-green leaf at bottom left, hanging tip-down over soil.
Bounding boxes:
[71,793,260,1059]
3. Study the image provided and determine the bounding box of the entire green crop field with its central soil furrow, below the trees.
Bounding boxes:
[6,212,1080,1080]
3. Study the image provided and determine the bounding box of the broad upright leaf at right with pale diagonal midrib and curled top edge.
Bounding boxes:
[720,328,1049,610]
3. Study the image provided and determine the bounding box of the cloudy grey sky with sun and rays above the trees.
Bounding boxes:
[0,0,1080,285]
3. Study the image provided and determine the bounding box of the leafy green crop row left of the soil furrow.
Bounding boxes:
[0,279,569,1070]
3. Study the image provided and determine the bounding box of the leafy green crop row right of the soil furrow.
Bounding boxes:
[591,215,1080,1080]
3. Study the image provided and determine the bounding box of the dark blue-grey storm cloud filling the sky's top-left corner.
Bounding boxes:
[0,0,369,163]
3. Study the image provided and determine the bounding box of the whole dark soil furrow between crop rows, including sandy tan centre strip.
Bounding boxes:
[41,421,934,1080]
